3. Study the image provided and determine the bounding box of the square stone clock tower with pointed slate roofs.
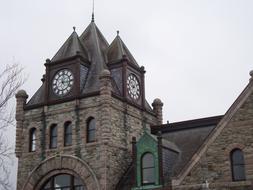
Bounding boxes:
[16,20,162,190]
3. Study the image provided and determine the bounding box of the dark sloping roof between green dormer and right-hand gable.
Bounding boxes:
[152,116,223,176]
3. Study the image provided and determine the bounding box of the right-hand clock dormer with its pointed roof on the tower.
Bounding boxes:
[107,32,146,109]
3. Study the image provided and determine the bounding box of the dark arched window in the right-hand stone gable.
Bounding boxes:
[230,149,246,181]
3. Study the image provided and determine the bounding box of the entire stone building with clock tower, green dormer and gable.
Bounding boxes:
[16,16,253,190]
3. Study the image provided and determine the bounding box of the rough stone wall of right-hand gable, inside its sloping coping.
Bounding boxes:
[173,91,253,190]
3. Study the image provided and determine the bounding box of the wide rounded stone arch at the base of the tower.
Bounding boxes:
[22,155,100,190]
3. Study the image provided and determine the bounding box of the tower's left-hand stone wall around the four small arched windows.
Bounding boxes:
[17,97,103,189]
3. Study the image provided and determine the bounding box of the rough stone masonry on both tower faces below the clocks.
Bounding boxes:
[17,97,156,189]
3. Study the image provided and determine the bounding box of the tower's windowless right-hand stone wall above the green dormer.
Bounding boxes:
[107,98,157,189]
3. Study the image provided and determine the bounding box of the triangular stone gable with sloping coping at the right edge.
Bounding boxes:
[173,81,253,188]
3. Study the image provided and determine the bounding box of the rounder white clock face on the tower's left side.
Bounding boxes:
[52,69,74,96]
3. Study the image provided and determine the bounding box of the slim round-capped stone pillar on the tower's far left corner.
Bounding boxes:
[15,90,28,158]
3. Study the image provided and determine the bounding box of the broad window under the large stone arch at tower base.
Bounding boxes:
[41,174,86,190]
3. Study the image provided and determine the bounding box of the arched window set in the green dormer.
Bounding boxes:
[141,153,155,185]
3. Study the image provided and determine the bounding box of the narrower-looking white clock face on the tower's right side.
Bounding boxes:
[127,74,140,100]
